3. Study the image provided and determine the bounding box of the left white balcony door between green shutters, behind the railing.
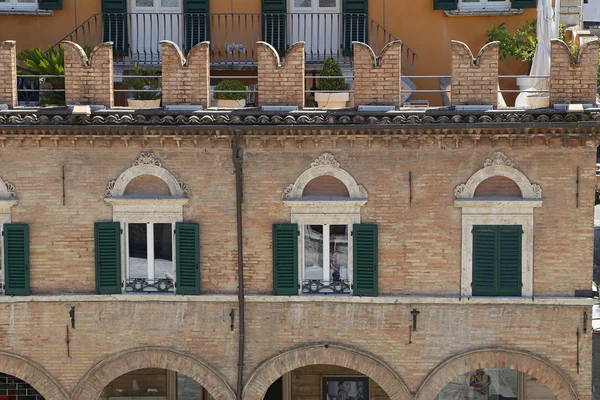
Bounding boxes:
[129,0,184,63]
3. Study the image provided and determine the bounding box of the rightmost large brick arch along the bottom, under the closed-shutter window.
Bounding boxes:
[415,348,578,400]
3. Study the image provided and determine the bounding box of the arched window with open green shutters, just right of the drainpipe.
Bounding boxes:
[273,153,378,296]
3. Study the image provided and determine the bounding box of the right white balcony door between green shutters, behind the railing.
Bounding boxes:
[288,0,342,61]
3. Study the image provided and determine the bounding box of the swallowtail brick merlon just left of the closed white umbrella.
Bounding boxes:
[451,40,500,106]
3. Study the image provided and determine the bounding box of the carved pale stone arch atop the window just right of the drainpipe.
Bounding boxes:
[282,153,368,200]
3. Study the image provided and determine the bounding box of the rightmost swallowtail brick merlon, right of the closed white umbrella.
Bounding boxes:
[550,39,598,106]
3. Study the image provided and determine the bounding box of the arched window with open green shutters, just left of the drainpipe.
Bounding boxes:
[95,153,200,294]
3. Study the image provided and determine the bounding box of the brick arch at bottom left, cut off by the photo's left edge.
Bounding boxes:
[0,350,69,400]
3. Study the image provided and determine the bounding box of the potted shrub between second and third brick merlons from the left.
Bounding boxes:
[123,63,161,109]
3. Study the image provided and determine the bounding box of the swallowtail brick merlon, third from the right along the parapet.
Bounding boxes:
[353,40,402,107]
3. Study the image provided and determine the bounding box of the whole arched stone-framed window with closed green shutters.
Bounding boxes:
[454,151,542,297]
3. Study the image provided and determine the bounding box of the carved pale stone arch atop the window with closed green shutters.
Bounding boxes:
[454,151,542,199]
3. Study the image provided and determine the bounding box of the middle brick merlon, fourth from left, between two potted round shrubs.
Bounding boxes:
[256,42,305,108]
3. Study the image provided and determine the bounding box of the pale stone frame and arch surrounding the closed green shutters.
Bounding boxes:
[454,151,542,297]
